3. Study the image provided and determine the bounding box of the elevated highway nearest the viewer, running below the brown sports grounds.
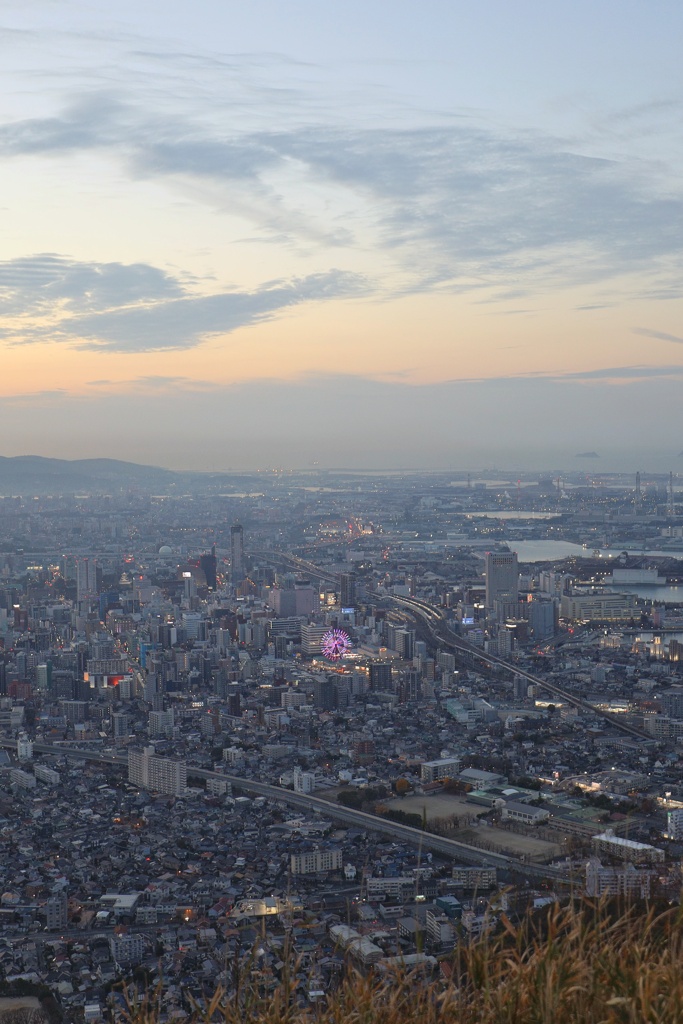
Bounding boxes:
[0,740,567,881]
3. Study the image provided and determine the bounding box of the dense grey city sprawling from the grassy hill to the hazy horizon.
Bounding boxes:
[0,467,683,1021]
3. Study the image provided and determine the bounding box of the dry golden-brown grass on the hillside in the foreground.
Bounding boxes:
[122,902,683,1024]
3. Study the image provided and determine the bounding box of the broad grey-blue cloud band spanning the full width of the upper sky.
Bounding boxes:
[0,93,683,295]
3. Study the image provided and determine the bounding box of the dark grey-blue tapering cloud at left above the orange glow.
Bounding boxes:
[0,254,367,352]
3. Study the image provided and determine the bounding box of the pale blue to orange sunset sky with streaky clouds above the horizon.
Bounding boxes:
[0,0,683,474]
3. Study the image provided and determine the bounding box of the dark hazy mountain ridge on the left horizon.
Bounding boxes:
[0,455,181,495]
